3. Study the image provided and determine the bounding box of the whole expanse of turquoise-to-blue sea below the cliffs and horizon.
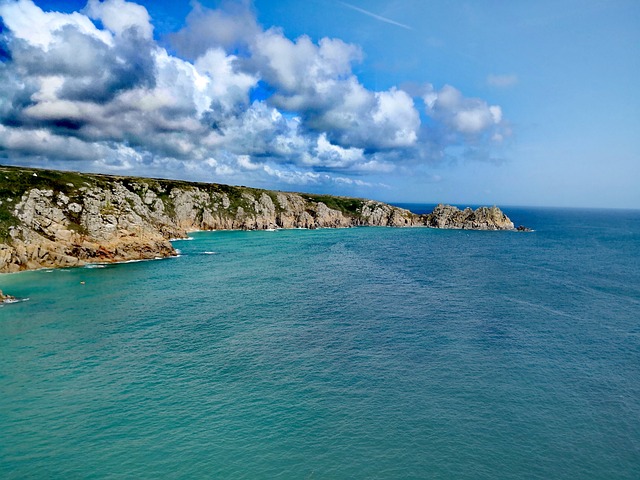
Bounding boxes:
[0,209,640,479]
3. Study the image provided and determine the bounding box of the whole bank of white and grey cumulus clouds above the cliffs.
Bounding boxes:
[0,0,506,193]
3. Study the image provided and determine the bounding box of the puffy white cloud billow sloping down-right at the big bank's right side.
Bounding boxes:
[252,28,420,149]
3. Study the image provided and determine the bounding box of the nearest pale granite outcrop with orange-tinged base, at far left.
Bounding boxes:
[0,182,184,272]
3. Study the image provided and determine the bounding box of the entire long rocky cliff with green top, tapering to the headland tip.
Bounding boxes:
[0,167,513,272]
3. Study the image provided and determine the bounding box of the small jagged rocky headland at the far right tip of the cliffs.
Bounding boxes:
[423,204,514,230]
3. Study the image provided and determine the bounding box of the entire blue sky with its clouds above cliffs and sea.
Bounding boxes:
[0,0,640,209]
